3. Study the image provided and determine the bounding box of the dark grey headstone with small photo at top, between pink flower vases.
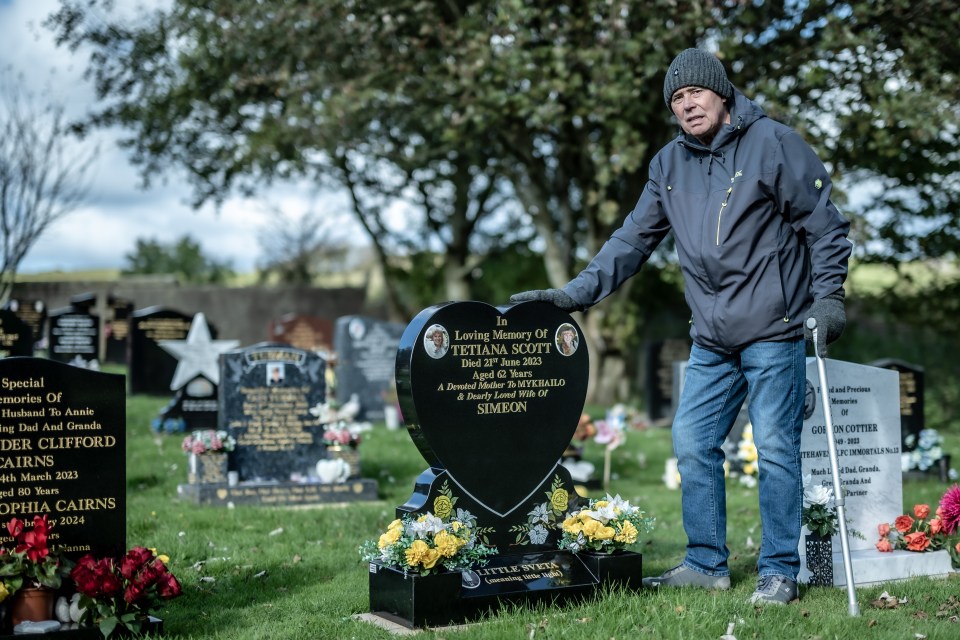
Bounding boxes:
[220,343,326,481]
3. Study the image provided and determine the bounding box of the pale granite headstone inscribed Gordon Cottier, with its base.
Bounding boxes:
[800,358,950,586]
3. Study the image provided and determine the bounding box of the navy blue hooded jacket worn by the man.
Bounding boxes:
[563,91,852,352]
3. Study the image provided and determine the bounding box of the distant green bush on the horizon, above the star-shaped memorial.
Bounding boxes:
[123,234,234,284]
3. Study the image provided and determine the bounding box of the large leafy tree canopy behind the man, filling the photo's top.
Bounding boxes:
[51,0,960,401]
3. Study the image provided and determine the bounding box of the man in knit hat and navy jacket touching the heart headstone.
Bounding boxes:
[511,49,851,604]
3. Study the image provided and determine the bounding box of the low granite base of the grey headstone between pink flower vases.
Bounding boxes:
[177,478,379,507]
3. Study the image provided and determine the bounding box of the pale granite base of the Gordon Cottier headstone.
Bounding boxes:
[797,541,953,587]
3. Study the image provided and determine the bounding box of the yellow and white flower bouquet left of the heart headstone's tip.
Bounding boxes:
[360,511,497,576]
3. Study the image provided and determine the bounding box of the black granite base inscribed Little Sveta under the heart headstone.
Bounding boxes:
[370,550,643,629]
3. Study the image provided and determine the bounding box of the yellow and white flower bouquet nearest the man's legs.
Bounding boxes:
[560,494,655,553]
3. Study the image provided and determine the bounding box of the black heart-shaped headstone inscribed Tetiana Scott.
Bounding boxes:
[397,302,588,518]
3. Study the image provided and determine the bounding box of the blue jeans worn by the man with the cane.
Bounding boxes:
[673,338,806,580]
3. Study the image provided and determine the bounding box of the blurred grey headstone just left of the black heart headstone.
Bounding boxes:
[333,316,406,420]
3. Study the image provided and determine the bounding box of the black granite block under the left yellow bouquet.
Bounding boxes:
[370,561,463,628]
